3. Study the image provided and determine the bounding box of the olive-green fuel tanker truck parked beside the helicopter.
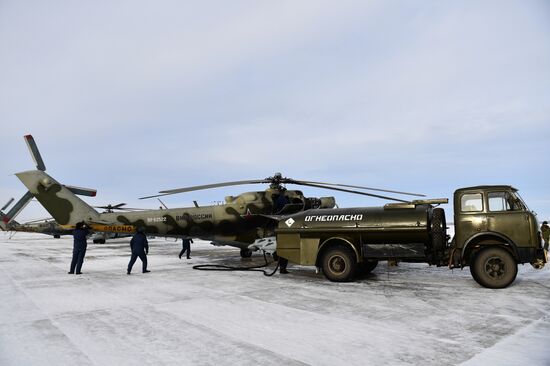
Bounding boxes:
[276,185,547,288]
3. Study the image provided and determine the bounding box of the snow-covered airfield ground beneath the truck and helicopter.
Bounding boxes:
[0,232,550,366]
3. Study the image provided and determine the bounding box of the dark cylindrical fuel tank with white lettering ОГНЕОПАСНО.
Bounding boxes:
[279,205,432,244]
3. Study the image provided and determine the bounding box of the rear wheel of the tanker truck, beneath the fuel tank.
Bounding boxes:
[323,246,357,282]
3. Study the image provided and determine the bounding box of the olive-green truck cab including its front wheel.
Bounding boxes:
[451,185,546,288]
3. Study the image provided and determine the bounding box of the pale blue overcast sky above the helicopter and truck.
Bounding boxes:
[0,0,550,220]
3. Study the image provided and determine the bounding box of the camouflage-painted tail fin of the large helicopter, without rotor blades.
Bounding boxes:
[15,170,99,226]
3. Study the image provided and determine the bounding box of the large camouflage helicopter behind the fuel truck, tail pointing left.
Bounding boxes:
[12,134,426,257]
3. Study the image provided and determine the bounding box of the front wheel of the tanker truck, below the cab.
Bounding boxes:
[470,247,518,288]
